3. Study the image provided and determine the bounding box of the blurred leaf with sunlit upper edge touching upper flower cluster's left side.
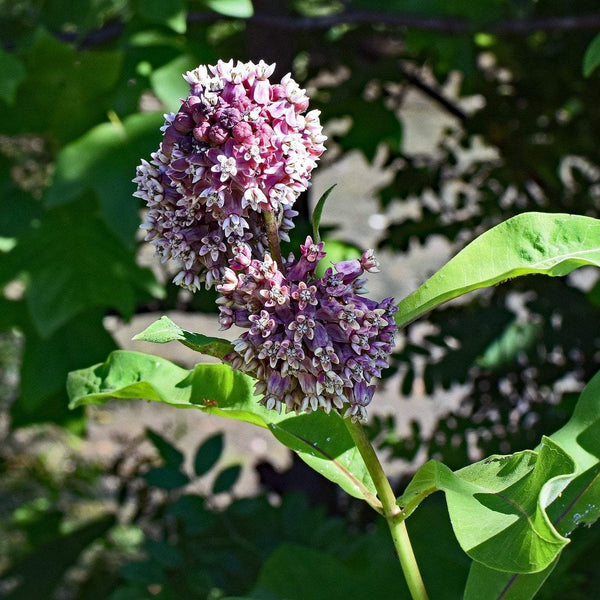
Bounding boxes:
[44,113,164,246]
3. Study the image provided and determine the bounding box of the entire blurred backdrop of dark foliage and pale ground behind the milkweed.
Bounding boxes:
[0,0,600,600]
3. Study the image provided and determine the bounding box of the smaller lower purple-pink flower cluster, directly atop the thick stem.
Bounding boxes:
[217,237,397,420]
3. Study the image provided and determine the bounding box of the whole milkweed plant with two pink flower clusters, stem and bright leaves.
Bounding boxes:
[68,61,600,600]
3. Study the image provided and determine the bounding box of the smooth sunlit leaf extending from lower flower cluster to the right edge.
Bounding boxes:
[396,213,600,327]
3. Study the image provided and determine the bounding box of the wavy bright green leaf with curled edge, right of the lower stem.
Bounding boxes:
[398,439,574,573]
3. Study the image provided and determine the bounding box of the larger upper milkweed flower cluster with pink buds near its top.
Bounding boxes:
[134,61,326,290]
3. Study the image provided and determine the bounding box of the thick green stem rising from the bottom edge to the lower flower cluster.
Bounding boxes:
[345,419,428,600]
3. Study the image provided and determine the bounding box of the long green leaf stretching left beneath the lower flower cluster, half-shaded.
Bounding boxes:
[67,350,381,508]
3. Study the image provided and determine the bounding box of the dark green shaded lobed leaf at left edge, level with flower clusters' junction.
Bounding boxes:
[0,202,163,337]
